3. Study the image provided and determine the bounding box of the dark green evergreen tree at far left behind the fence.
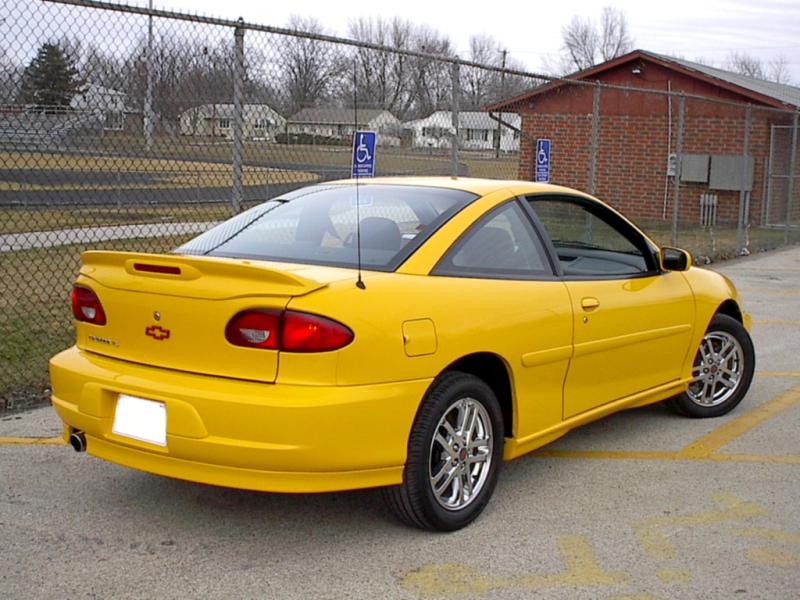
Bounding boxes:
[20,43,85,109]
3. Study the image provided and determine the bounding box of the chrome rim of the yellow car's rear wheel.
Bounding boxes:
[428,398,493,510]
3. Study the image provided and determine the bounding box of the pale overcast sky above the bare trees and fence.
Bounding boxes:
[0,0,800,86]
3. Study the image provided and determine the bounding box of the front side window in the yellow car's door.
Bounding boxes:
[528,197,655,278]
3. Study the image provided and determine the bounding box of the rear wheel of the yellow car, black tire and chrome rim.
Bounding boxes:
[384,371,503,531]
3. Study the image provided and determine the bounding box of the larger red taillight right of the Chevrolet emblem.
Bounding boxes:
[225,309,353,352]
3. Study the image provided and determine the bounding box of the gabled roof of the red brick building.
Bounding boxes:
[487,50,800,110]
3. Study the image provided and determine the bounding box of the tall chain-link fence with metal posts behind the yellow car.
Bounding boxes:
[0,0,800,410]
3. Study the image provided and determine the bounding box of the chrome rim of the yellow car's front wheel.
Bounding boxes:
[687,331,744,407]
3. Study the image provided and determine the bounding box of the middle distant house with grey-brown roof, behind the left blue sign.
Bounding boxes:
[286,108,402,146]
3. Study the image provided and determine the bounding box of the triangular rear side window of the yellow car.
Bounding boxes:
[433,201,552,279]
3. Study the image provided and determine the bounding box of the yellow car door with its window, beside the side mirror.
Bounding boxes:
[528,195,694,419]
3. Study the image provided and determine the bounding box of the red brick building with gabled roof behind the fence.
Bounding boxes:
[487,50,800,226]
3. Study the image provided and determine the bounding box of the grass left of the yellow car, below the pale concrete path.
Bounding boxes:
[0,235,192,412]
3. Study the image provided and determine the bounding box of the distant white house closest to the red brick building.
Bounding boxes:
[403,110,520,152]
